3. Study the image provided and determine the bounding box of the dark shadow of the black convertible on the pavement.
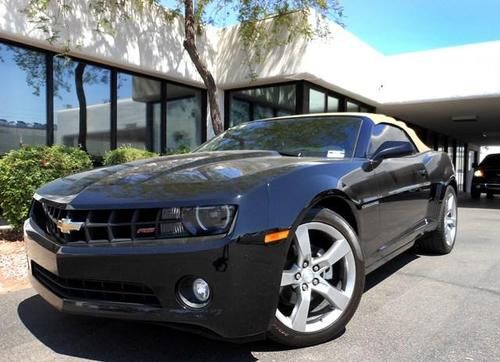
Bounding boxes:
[17,251,419,361]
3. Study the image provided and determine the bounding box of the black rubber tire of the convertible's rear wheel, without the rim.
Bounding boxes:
[418,186,458,255]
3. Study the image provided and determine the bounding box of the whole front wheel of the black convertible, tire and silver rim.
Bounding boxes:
[269,209,365,347]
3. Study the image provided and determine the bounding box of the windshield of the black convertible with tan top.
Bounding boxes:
[195,116,361,158]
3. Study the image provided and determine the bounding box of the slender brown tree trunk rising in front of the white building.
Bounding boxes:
[184,0,224,135]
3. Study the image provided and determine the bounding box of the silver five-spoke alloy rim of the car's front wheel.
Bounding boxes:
[276,222,356,333]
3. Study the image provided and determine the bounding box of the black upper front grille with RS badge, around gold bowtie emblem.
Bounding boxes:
[30,200,189,245]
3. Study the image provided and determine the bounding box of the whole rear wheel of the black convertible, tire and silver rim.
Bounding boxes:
[418,186,457,254]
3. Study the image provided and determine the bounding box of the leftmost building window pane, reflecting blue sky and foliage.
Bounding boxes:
[0,44,47,154]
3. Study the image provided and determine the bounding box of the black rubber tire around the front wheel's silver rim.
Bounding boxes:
[268,209,365,347]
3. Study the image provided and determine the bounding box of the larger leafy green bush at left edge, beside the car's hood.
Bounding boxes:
[0,146,92,231]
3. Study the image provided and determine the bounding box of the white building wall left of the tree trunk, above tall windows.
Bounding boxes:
[0,0,211,86]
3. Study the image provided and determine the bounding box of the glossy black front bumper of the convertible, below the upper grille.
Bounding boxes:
[25,220,287,340]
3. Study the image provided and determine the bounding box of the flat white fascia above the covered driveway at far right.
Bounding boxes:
[378,41,500,103]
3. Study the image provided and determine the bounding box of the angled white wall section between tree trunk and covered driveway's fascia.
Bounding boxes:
[216,14,384,103]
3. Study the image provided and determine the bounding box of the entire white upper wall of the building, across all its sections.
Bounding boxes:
[0,0,500,111]
